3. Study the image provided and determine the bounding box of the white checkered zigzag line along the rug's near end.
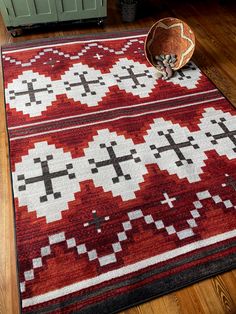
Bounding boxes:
[20,185,236,292]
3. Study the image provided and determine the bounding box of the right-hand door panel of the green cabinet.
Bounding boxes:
[56,0,106,21]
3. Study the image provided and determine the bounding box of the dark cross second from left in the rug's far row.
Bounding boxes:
[64,71,105,97]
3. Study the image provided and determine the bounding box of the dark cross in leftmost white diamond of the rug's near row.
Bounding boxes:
[17,155,75,203]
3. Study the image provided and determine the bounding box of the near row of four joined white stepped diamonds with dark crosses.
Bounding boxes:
[13,108,236,222]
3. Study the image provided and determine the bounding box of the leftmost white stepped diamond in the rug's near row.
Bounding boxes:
[13,142,80,223]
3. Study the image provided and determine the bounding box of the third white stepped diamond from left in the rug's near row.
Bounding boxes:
[142,118,207,183]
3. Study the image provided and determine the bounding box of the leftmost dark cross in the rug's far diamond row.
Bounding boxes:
[9,78,53,107]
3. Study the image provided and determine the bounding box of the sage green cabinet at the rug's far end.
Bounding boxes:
[0,0,107,29]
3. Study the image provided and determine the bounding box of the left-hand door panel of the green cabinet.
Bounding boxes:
[4,0,57,26]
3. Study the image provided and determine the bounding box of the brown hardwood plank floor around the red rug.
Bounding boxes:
[0,0,236,314]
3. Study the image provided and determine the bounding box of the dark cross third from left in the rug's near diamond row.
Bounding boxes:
[150,129,199,167]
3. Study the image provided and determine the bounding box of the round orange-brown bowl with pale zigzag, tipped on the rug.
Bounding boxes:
[144,17,195,70]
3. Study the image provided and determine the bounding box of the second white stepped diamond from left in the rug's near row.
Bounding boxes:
[84,129,147,201]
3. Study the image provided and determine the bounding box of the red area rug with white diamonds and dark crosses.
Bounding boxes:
[2,31,236,314]
